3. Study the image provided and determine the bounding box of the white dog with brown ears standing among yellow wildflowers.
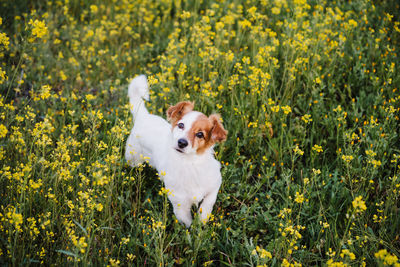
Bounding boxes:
[125,75,227,227]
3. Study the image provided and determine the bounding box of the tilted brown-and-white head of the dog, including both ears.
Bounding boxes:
[167,101,228,154]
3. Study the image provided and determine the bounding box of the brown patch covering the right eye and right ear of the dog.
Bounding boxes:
[188,114,228,154]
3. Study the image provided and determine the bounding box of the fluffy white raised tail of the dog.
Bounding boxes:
[128,75,149,117]
